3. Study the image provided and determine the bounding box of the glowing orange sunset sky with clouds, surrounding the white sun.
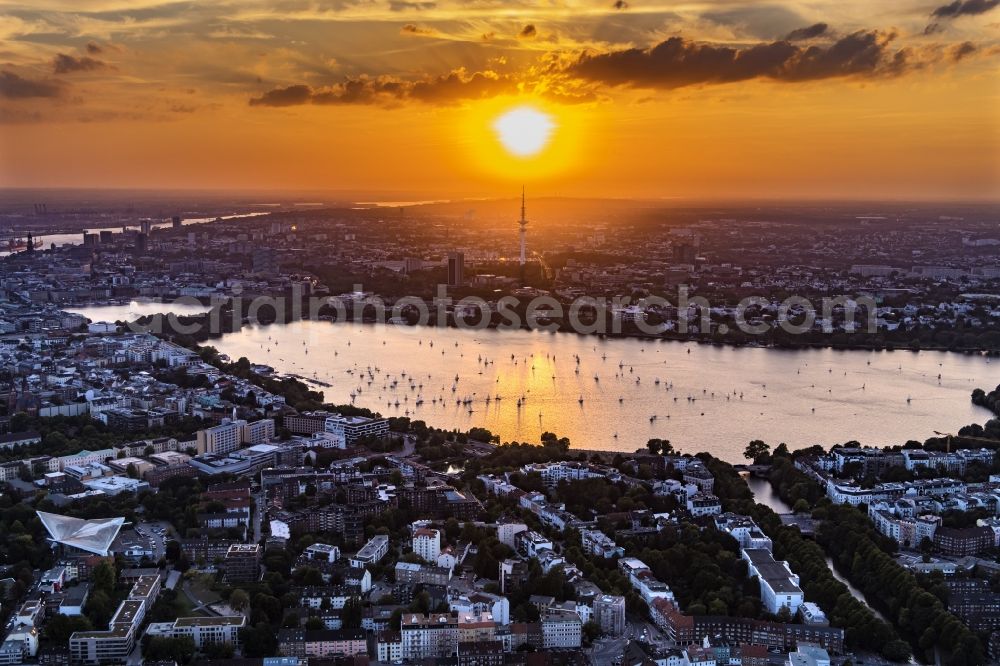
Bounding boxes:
[0,0,1000,199]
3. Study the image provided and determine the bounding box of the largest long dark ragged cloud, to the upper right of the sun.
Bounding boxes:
[564,30,907,89]
